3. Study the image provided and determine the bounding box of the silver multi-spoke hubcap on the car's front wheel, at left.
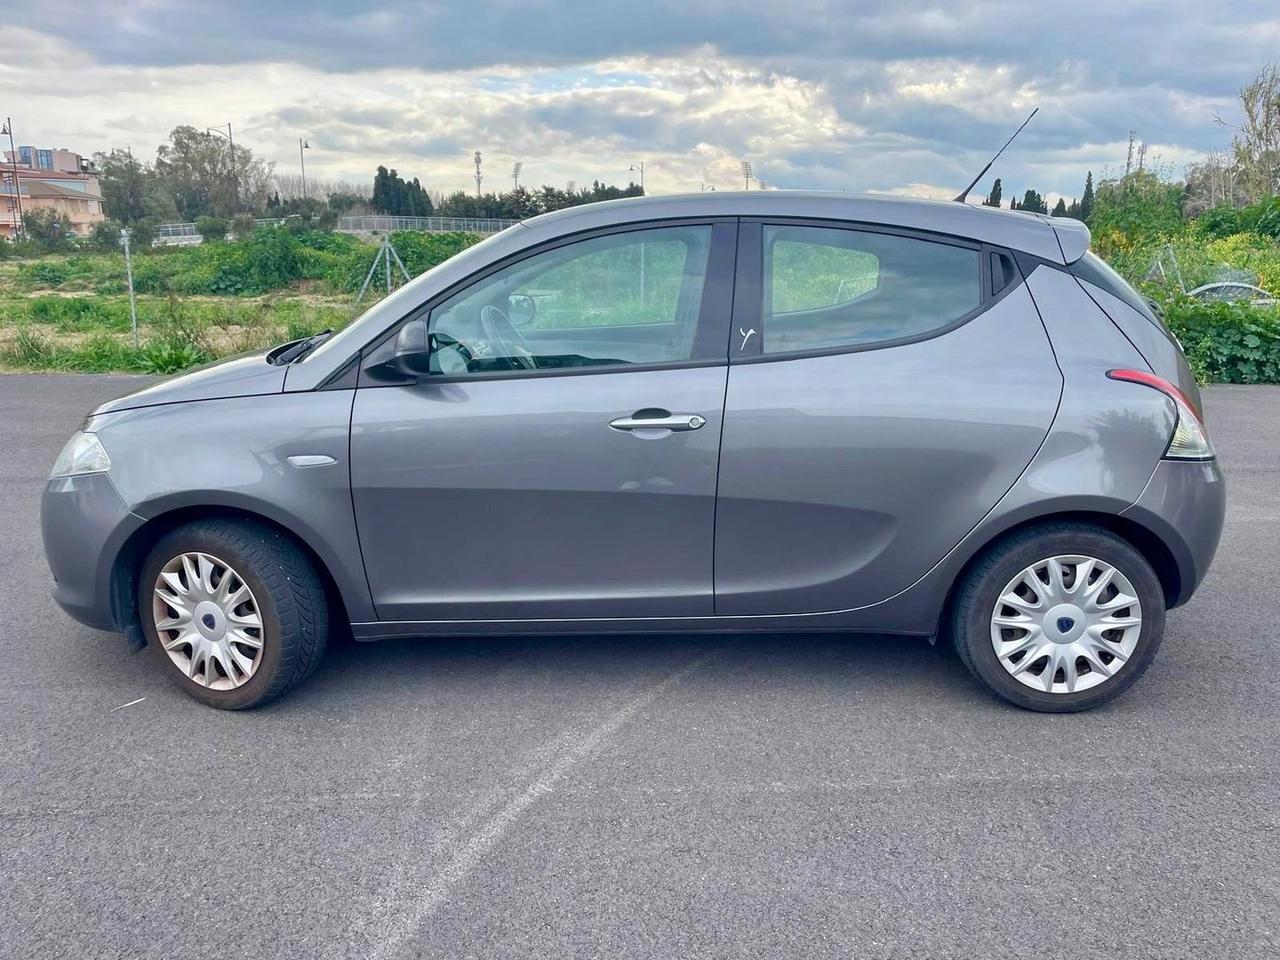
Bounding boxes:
[152,553,262,690]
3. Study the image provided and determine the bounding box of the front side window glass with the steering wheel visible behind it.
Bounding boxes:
[429,225,712,375]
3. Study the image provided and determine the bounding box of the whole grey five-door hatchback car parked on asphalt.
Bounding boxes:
[42,192,1225,712]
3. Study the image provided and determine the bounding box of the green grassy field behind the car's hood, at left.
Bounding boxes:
[0,229,479,372]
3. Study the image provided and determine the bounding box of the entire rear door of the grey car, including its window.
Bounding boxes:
[716,220,1061,614]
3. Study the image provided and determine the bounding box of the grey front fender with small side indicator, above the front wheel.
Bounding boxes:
[95,390,374,621]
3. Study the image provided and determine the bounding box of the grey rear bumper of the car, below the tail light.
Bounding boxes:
[1120,460,1226,607]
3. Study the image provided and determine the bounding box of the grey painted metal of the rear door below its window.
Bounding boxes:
[716,287,1061,614]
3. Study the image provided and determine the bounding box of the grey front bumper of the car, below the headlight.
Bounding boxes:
[40,474,143,630]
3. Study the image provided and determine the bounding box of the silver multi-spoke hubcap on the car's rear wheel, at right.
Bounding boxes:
[991,556,1142,694]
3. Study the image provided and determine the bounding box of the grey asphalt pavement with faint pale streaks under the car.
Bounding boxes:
[0,375,1280,960]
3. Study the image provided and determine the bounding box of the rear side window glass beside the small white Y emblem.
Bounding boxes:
[762,225,982,353]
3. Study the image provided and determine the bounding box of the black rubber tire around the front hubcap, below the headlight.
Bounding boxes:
[138,518,329,710]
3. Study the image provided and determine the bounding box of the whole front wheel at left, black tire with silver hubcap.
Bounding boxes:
[138,520,329,710]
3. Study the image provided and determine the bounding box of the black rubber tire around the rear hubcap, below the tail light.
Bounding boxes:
[951,524,1165,713]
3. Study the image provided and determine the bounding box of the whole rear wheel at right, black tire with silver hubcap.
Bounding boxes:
[952,524,1165,713]
